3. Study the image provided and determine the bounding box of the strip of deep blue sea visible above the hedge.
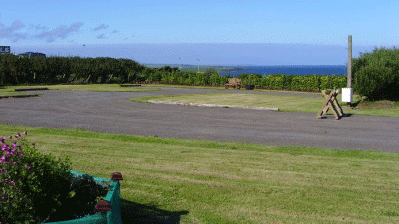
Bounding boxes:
[219,65,347,77]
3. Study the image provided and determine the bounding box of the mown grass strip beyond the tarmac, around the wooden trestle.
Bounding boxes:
[131,91,399,117]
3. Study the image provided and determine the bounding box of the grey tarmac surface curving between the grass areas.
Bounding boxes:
[0,88,399,152]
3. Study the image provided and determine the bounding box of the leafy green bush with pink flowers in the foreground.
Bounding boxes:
[0,132,71,224]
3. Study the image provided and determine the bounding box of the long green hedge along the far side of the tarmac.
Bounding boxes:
[0,54,346,91]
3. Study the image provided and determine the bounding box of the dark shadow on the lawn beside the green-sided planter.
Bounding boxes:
[121,199,189,224]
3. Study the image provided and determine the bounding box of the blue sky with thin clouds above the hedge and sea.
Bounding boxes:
[0,0,399,65]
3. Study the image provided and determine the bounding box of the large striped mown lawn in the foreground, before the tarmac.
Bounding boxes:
[0,124,399,223]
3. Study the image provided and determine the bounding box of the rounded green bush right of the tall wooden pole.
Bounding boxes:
[352,48,399,100]
